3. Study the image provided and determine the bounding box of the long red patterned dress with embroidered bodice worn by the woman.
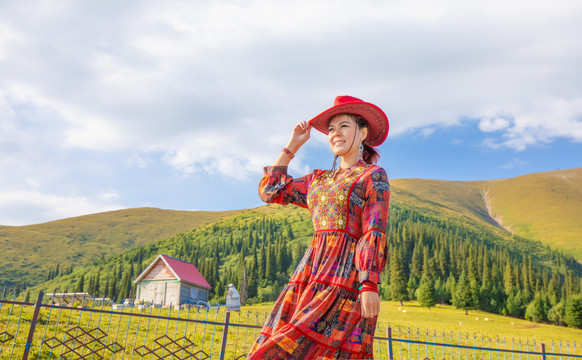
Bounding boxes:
[248,161,390,360]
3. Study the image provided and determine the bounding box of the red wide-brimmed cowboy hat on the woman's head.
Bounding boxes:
[309,95,389,147]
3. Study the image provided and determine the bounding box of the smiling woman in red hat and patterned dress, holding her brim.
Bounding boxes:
[248,96,390,360]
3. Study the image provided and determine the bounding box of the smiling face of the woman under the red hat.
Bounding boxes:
[327,114,368,157]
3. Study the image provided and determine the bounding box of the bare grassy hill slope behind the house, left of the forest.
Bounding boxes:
[0,208,243,284]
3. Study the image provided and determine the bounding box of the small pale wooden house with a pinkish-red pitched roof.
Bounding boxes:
[133,254,212,305]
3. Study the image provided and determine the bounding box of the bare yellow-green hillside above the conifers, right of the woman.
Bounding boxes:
[390,168,582,261]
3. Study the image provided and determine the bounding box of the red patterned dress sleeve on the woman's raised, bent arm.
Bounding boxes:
[259,166,314,208]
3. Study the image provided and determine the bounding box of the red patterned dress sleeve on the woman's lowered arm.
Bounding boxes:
[356,167,390,283]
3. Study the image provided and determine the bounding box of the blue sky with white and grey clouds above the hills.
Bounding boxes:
[0,0,582,226]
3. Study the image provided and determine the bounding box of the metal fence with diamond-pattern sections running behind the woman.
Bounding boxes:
[0,293,582,360]
